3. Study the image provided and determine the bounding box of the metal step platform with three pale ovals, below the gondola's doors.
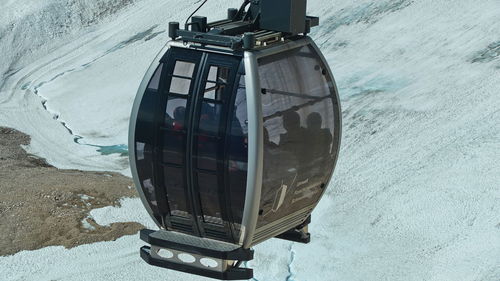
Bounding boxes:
[140,229,254,280]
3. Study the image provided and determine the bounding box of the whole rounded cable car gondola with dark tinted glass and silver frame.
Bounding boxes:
[129,0,341,280]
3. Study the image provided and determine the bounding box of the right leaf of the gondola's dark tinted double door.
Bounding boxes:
[191,54,241,241]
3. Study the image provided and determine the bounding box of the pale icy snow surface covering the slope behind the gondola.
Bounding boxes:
[0,0,500,281]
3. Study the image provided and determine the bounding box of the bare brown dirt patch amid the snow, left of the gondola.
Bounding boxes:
[0,127,143,256]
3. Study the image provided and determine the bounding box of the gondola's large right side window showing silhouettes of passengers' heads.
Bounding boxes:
[257,46,336,228]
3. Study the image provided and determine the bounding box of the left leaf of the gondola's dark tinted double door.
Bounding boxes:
[155,47,202,235]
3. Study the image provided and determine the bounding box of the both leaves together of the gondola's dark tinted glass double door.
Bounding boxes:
[154,47,247,242]
